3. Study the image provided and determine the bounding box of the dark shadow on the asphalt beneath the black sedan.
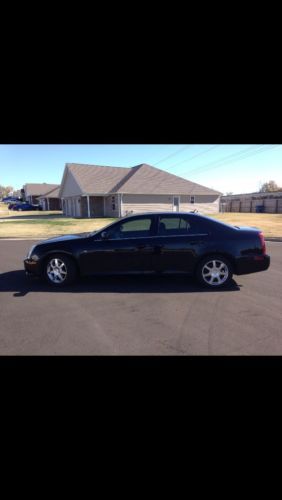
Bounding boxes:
[0,270,240,297]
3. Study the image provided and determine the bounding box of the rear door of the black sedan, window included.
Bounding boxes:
[154,214,208,273]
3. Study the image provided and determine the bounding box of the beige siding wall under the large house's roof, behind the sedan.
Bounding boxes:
[122,194,219,215]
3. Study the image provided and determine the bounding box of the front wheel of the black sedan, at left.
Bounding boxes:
[44,254,78,288]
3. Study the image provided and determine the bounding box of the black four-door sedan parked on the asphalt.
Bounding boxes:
[24,212,270,289]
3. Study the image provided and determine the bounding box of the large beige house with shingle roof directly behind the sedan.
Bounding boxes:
[59,163,221,217]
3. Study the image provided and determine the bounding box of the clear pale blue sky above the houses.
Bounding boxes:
[0,144,282,193]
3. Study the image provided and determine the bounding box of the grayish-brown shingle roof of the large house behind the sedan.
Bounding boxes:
[62,163,221,195]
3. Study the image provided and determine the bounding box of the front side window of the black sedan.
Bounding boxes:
[109,217,152,239]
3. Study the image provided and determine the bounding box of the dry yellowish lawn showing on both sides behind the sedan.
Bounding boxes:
[0,206,282,239]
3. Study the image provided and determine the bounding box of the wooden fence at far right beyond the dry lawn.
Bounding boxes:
[220,191,282,214]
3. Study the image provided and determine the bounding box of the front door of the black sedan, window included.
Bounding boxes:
[80,216,155,274]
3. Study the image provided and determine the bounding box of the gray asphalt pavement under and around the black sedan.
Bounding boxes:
[0,240,282,355]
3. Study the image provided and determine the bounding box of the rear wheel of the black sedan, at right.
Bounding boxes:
[196,255,233,289]
